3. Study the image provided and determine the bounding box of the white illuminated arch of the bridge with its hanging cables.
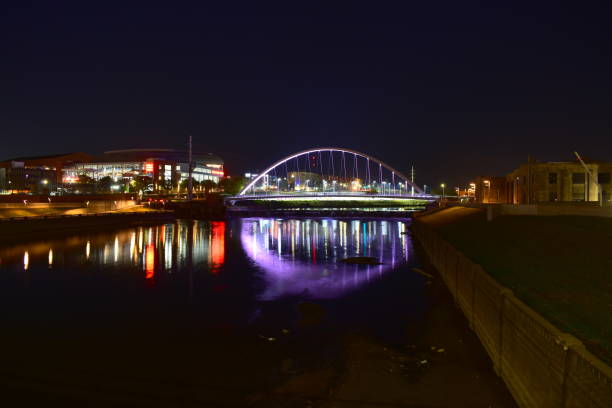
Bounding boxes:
[237,147,424,197]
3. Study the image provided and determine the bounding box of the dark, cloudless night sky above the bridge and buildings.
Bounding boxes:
[0,0,612,185]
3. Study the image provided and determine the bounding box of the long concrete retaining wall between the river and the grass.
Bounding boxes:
[413,220,612,408]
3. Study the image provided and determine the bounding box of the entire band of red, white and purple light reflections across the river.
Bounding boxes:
[0,218,411,300]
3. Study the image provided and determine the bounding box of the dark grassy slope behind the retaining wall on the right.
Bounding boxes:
[419,207,612,363]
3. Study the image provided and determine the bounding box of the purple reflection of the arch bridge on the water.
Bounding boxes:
[240,218,410,300]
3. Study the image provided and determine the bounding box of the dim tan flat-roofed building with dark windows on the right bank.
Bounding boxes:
[506,161,612,205]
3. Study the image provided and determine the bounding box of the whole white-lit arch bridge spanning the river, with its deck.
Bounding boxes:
[229,147,437,202]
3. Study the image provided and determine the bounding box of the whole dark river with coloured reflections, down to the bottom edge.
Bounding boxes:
[0,218,513,406]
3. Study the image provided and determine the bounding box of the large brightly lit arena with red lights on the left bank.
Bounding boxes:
[62,149,224,192]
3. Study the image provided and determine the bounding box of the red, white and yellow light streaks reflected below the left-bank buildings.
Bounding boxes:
[0,221,226,279]
